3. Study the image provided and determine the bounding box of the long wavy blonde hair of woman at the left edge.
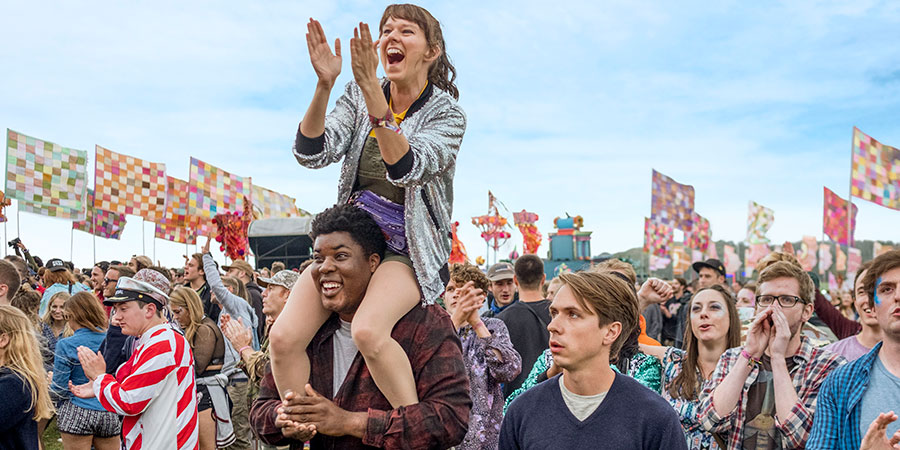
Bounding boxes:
[0,306,53,420]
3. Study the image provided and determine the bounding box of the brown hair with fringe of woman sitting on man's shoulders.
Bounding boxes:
[378,3,459,100]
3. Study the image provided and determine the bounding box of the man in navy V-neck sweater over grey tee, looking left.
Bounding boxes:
[500,272,687,450]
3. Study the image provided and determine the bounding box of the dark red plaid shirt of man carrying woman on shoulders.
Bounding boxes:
[250,305,472,449]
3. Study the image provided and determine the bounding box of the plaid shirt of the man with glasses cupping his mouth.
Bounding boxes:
[698,336,846,449]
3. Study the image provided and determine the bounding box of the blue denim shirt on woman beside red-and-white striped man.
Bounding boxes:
[51,328,106,411]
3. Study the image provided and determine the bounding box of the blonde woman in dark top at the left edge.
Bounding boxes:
[0,306,53,450]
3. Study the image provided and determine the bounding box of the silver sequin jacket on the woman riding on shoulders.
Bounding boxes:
[294,81,466,304]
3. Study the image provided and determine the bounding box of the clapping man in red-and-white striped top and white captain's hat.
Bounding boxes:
[69,269,199,449]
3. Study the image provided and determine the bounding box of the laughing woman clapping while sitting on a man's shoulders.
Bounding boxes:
[270,4,466,408]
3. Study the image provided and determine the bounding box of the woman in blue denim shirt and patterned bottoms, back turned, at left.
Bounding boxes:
[51,292,122,450]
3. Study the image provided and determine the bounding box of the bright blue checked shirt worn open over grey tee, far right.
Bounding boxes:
[807,342,881,449]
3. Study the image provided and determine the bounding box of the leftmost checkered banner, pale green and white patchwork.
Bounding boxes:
[6,129,87,218]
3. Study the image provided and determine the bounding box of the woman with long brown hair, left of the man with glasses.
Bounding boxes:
[641,285,741,450]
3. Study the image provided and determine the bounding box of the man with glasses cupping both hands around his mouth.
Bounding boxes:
[699,261,846,449]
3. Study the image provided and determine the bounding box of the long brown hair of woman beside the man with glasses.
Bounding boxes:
[667,284,741,400]
